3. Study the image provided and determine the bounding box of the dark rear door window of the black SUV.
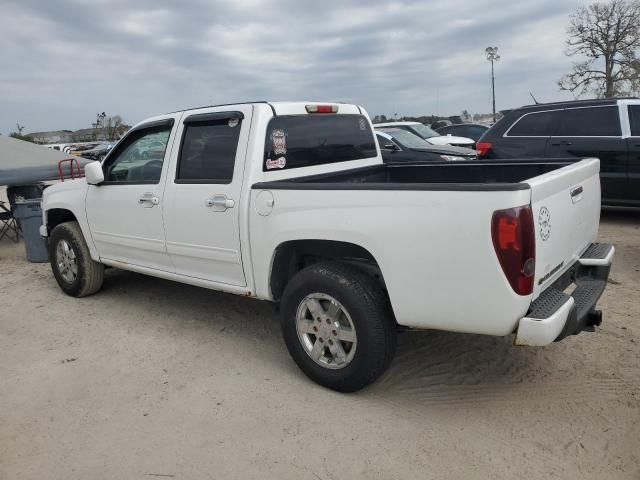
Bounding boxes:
[554,105,621,137]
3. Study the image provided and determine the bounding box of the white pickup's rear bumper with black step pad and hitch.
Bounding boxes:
[515,243,615,346]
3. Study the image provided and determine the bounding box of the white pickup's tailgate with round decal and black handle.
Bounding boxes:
[526,158,600,298]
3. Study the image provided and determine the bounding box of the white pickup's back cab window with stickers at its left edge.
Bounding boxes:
[262,114,377,172]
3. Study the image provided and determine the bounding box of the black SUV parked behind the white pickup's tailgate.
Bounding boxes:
[476,98,640,207]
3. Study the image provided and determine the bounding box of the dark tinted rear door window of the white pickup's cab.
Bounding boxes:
[175,113,242,184]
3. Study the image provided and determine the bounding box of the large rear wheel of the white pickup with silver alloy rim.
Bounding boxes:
[281,262,396,392]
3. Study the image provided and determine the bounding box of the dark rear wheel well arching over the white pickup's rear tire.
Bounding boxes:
[269,240,387,301]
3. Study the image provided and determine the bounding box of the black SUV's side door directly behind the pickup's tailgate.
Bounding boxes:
[545,105,627,204]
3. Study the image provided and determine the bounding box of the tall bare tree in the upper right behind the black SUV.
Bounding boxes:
[558,0,640,98]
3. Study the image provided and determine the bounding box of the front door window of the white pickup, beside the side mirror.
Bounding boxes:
[103,123,173,184]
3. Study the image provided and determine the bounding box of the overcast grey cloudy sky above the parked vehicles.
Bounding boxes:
[0,0,580,134]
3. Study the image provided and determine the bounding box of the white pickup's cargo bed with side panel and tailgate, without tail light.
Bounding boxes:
[250,159,600,335]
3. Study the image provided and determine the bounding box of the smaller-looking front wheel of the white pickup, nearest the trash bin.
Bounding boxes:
[49,222,104,297]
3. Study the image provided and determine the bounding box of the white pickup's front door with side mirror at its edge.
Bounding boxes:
[85,116,179,271]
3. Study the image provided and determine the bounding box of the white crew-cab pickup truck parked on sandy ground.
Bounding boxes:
[41,102,614,392]
